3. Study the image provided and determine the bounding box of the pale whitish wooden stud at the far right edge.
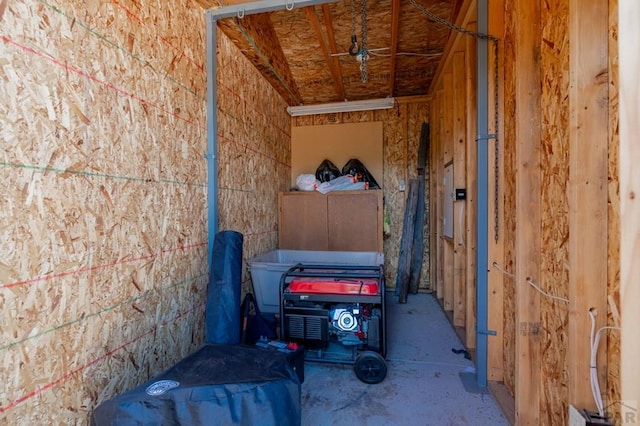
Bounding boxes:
[618,0,640,424]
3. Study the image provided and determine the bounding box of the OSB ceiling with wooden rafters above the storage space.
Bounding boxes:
[196,0,463,105]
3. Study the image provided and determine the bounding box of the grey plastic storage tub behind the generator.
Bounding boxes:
[248,250,384,314]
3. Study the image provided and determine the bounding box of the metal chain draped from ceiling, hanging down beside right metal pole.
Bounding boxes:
[409,0,500,243]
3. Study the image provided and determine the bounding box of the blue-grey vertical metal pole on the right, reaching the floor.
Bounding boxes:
[476,0,493,388]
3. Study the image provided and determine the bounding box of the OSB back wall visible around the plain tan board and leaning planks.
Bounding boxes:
[293,102,429,290]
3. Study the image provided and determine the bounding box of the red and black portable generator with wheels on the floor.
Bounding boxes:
[280,264,387,384]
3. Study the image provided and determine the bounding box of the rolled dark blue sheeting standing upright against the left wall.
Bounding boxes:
[205,231,243,344]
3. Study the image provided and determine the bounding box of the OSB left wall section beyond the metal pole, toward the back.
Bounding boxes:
[217,24,291,282]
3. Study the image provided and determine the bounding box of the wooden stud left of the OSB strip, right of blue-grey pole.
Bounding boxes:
[513,0,542,425]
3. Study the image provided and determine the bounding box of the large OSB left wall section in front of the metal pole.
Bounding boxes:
[0,0,208,424]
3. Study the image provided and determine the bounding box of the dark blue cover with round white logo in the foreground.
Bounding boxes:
[91,344,301,426]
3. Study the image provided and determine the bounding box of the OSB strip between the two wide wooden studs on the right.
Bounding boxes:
[536,0,569,424]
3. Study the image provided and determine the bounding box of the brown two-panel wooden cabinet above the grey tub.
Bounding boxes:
[278,190,382,252]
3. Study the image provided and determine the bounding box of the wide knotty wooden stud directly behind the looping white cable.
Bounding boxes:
[567,0,609,409]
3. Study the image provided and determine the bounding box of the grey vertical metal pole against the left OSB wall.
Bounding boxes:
[205,11,218,269]
